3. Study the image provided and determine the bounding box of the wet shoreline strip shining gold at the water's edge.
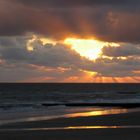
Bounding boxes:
[0,107,140,128]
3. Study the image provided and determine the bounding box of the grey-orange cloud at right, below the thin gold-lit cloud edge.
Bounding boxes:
[89,58,140,77]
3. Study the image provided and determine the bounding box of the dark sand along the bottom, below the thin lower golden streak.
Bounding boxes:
[0,129,140,140]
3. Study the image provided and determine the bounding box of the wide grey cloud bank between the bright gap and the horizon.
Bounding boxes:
[0,36,140,82]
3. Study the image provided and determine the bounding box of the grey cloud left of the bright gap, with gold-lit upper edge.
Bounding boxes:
[0,37,87,67]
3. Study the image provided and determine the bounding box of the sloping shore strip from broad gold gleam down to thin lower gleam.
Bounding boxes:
[0,109,140,129]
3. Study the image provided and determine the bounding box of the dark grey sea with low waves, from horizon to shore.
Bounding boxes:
[0,83,140,124]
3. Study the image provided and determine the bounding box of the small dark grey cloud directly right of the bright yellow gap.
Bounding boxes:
[102,44,140,57]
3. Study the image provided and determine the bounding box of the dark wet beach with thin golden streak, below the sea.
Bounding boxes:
[0,108,140,140]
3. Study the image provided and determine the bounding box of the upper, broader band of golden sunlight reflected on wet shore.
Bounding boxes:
[0,108,139,125]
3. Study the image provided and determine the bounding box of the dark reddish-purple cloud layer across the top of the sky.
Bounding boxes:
[0,0,140,42]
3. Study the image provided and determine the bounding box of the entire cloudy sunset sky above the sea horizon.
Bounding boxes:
[0,0,140,83]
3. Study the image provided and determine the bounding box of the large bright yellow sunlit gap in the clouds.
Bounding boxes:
[64,38,106,60]
